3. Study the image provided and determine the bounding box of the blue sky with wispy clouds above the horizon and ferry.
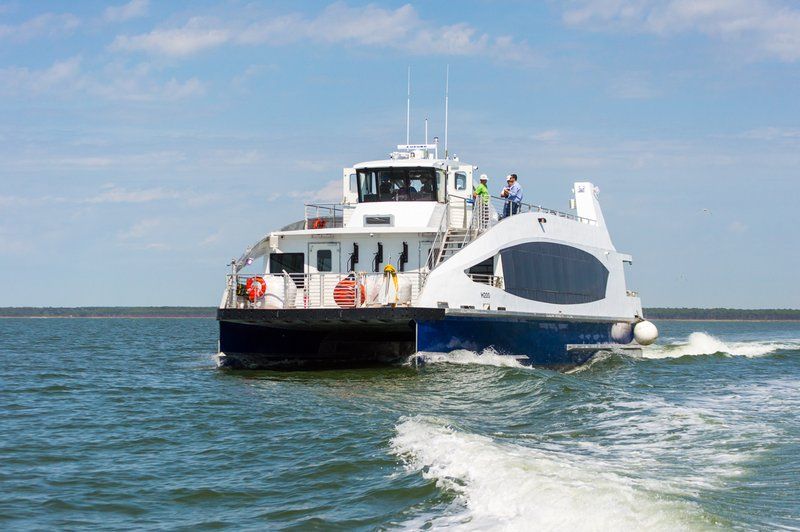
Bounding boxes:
[0,0,800,308]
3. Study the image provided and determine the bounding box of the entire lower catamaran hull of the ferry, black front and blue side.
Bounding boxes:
[217,308,630,369]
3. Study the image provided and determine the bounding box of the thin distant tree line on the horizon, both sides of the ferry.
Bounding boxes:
[0,307,800,321]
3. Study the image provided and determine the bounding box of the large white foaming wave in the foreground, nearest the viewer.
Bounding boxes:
[391,417,699,530]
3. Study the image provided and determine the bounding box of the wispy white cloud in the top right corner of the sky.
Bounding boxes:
[564,0,800,62]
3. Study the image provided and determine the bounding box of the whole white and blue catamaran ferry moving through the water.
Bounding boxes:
[217,139,658,369]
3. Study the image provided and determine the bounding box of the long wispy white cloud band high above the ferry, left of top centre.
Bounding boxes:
[111,2,541,64]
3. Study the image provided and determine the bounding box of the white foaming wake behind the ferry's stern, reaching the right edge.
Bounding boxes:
[642,332,800,359]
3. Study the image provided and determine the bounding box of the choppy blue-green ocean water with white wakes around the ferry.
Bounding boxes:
[0,319,800,530]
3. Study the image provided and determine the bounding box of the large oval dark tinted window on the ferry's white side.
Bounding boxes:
[500,242,608,305]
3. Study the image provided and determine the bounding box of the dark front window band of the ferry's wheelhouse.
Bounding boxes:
[358,168,437,202]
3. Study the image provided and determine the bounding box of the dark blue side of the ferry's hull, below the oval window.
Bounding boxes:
[417,316,621,368]
